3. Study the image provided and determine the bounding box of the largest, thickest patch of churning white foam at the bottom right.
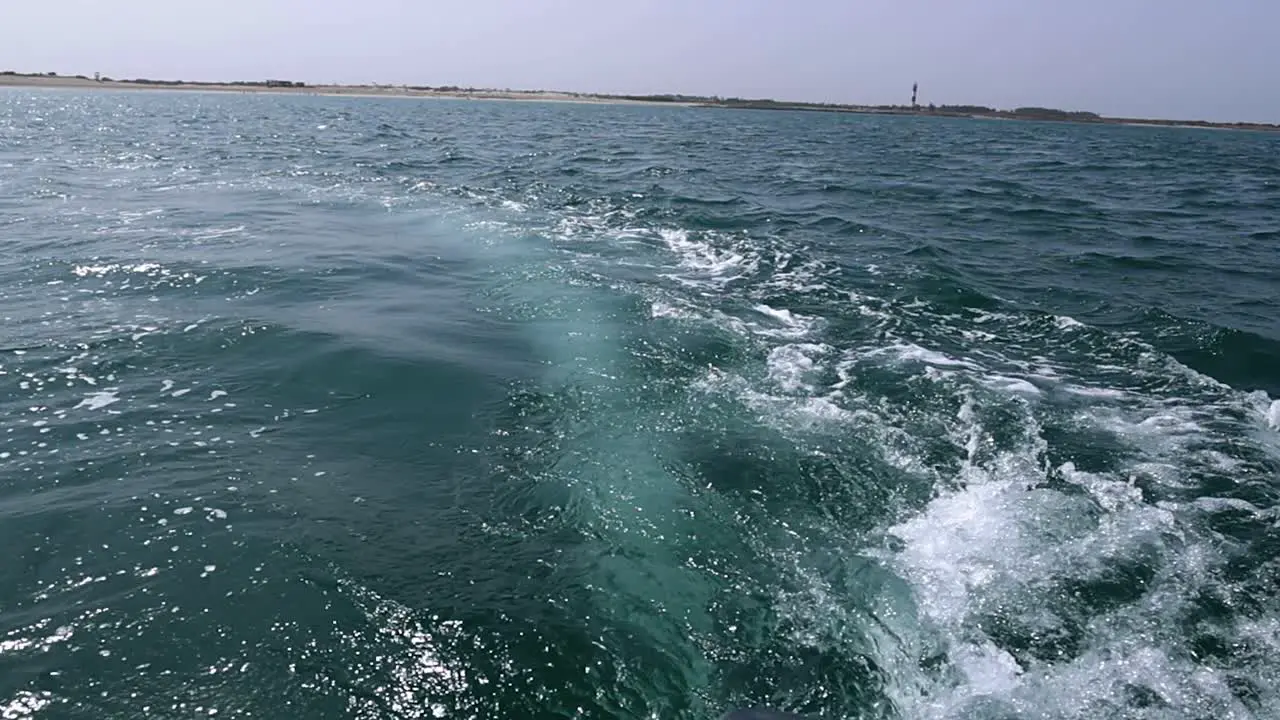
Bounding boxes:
[888,381,1280,717]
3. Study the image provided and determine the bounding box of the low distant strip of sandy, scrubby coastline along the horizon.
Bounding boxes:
[0,72,1280,132]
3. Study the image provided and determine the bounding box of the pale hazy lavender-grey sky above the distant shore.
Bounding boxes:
[0,0,1280,122]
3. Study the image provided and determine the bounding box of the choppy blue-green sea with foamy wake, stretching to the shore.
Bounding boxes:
[0,91,1280,719]
